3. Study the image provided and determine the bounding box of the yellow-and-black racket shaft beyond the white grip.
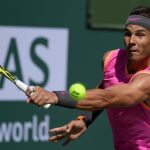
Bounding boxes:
[0,65,15,83]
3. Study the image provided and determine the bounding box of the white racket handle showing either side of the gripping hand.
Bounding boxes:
[15,80,51,109]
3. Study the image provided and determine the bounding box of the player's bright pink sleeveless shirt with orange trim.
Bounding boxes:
[103,49,150,150]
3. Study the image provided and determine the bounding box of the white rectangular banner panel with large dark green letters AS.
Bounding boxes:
[0,26,69,101]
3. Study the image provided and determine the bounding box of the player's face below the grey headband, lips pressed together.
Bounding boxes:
[124,24,150,62]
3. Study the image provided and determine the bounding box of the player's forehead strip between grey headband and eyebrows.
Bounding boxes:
[125,24,150,32]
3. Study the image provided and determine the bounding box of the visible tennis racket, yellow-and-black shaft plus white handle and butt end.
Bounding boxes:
[0,65,51,109]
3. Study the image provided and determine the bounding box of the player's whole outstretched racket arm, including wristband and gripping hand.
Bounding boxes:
[26,51,150,111]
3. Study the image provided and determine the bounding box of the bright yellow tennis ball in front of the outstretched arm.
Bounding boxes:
[69,83,86,100]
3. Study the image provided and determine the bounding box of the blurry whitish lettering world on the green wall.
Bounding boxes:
[0,115,50,143]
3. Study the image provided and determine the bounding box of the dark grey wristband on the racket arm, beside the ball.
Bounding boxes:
[53,91,77,108]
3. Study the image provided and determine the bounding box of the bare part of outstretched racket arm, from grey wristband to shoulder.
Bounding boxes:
[76,73,150,111]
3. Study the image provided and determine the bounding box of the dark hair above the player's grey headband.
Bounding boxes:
[129,6,150,18]
